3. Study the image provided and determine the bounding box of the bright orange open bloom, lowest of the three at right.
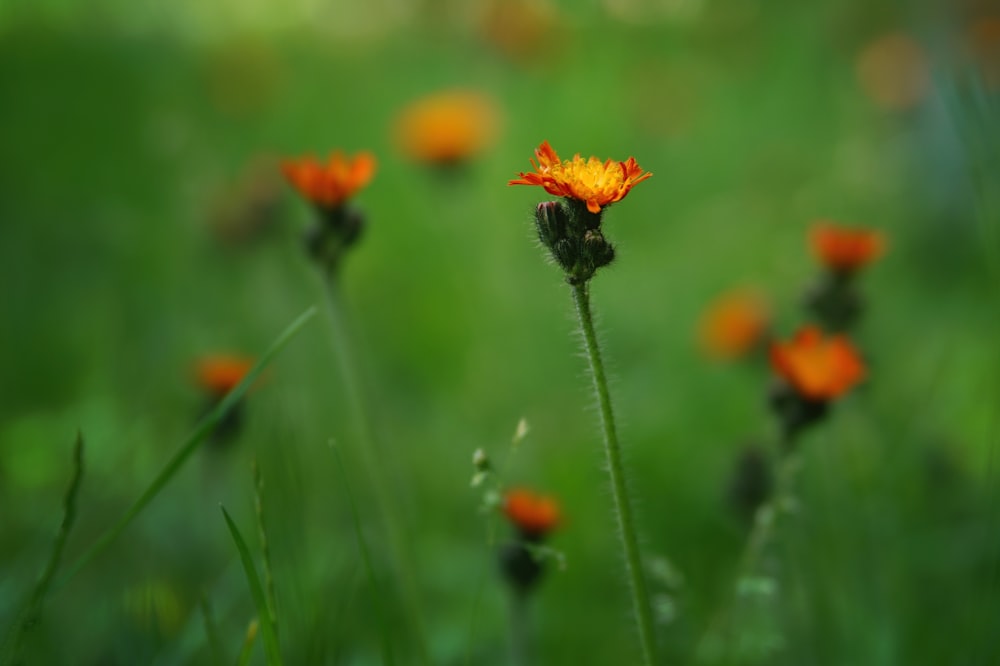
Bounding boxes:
[771,326,865,402]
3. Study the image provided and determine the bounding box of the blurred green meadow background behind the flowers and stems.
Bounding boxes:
[0,0,1000,664]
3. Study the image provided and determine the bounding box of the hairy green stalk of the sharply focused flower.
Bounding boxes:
[573,283,655,666]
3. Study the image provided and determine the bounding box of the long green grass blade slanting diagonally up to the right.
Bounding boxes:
[57,307,316,586]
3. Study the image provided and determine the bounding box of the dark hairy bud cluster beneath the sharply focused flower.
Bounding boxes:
[535,200,615,285]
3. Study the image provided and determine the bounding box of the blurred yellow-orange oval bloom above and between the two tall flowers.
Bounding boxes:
[395,90,499,164]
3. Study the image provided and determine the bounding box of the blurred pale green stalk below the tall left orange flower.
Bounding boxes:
[323,271,430,664]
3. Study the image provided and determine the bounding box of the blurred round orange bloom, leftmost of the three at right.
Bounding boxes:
[699,289,771,359]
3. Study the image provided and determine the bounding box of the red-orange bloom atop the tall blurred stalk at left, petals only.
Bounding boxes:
[281,150,375,209]
